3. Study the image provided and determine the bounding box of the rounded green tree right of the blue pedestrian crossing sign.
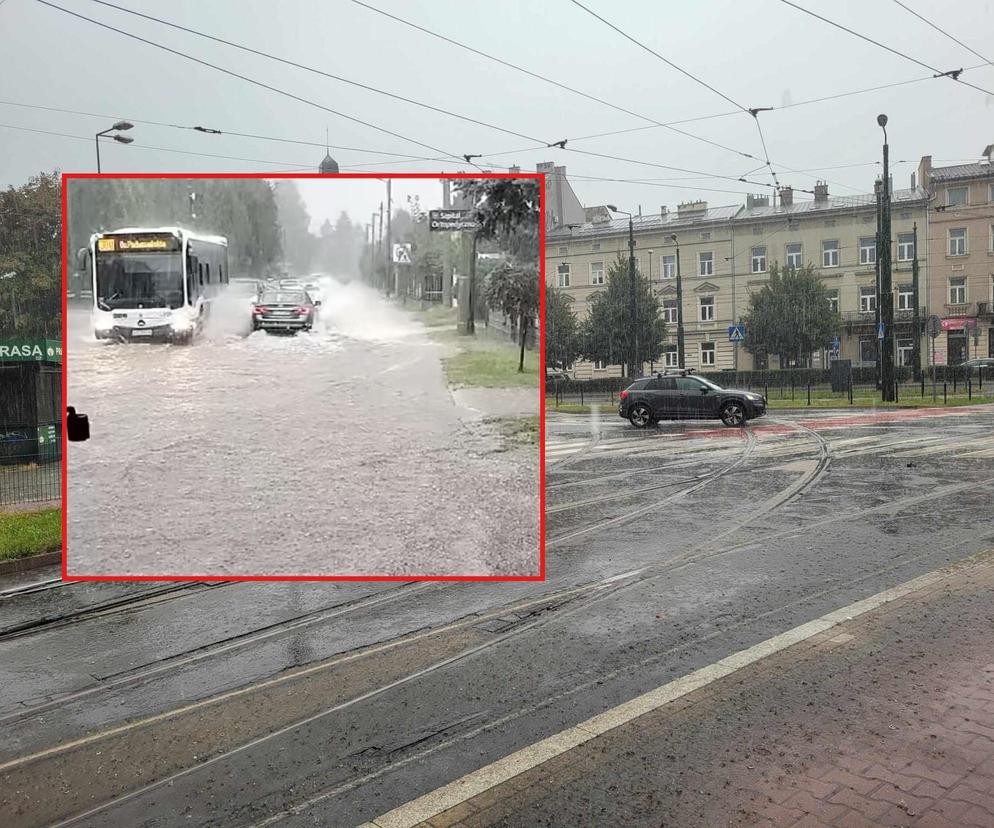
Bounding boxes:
[742,264,842,366]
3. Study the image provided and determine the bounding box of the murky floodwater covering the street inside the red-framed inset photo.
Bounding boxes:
[67,280,539,576]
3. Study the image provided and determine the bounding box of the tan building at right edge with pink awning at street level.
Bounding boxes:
[917,155,994,365]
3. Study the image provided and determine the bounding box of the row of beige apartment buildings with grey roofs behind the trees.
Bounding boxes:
[546,146,994,379]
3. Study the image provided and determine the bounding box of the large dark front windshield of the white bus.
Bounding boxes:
[97,252,183,310]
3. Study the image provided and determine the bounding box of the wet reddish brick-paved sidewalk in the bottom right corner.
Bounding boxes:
[414,555,994,828]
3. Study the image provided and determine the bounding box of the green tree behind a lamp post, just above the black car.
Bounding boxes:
[580,256,666,377]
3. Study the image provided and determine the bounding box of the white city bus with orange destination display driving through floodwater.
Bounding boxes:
[77,227,228,343]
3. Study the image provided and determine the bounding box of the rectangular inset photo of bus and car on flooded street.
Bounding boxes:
[63,173,545,580]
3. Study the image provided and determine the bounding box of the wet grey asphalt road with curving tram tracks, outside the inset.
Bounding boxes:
[0,407,994,826]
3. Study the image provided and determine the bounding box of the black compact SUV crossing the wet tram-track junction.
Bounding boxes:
[618,370,766,428]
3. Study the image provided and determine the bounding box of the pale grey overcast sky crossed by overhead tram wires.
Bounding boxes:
[0,0,994,222]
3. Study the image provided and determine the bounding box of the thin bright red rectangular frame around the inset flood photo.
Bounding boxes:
[62,172,546,583]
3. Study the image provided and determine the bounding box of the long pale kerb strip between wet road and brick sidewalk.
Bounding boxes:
[356,556,976,828]
